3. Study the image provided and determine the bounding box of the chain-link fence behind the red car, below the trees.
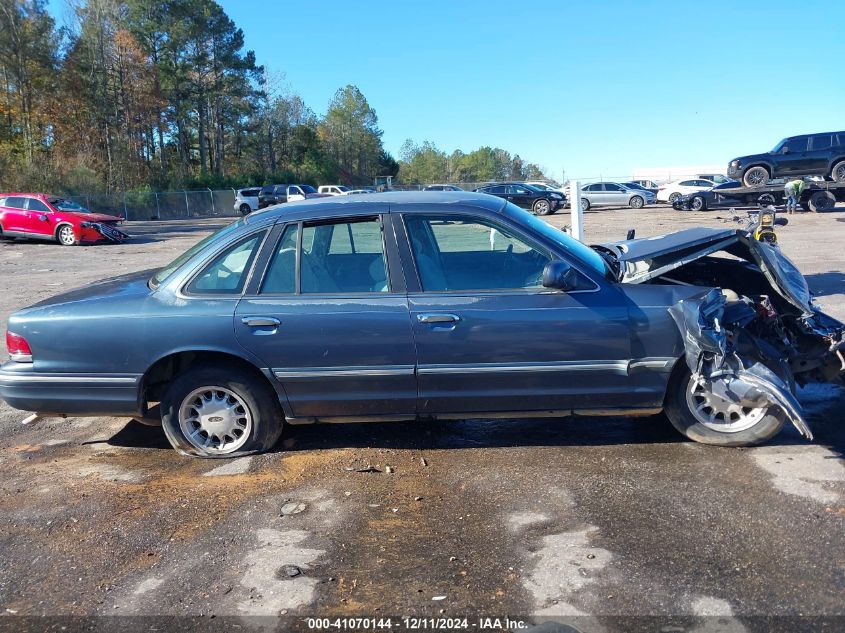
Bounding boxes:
[65,189,240,220]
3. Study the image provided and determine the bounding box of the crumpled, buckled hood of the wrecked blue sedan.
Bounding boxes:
[598,227,816,316]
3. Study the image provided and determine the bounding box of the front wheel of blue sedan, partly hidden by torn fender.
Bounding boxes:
[666,359,784,446]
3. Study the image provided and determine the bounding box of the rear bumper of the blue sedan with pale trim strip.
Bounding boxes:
[0,362,141,416]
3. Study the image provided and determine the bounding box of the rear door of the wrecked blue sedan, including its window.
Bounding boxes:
[235,213,417,420]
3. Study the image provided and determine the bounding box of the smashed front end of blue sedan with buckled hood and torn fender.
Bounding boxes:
[594,229,845,439]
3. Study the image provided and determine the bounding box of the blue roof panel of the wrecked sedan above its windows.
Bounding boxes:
[245,191,507,223]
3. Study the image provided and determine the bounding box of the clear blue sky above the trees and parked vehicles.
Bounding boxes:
[52,0,845,178]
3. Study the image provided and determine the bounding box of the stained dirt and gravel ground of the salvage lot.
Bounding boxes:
[0,207,845,633]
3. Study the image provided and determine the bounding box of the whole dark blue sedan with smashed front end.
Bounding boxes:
[0,192,845,457]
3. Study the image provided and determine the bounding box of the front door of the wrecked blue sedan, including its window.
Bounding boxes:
[403,212,640,415]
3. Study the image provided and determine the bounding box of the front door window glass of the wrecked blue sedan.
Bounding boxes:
[404,215,568,292]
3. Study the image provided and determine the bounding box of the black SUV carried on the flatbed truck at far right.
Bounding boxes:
[728,132,845,187]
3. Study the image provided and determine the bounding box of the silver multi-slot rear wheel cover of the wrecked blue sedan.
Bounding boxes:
[179,387,252,455]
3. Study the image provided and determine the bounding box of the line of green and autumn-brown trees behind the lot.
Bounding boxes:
[0,0,542,193]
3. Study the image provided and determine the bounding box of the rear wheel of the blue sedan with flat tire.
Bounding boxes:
[161,366,283,457]
